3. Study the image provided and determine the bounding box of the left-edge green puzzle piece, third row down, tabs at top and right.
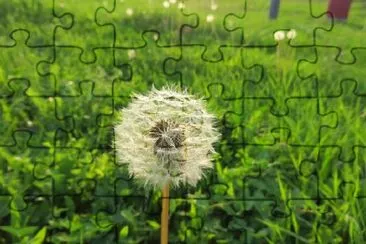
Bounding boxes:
[0,79,71,146]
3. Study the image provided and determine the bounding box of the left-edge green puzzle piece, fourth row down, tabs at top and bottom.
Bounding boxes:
[0,130,54,207]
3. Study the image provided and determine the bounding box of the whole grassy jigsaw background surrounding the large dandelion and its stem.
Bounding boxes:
[0,0,366,243]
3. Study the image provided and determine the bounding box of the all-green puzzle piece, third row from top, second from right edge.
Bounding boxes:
[225,98,337,146]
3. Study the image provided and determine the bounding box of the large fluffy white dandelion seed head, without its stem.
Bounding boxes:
[115,87,220,191]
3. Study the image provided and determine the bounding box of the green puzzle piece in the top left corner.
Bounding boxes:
[0,0,72,46]
